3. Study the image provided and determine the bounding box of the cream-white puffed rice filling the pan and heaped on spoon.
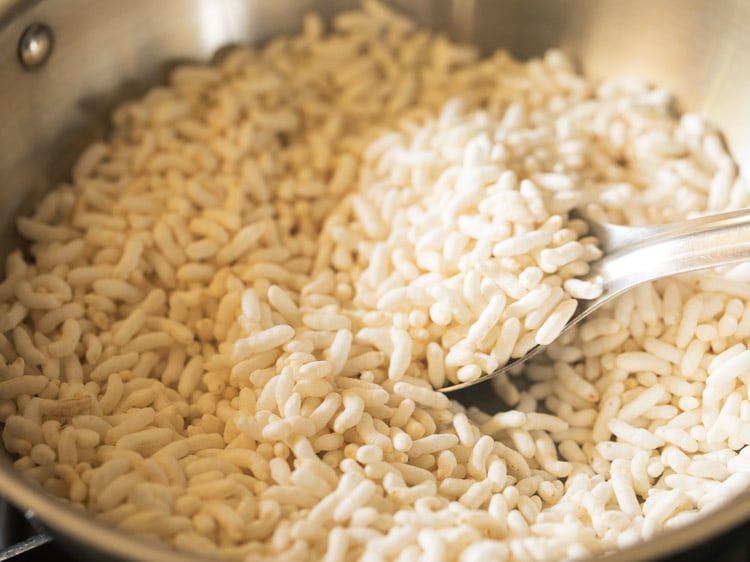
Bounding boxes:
[0,1,750,562]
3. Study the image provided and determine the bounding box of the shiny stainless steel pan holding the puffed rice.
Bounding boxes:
[0,0,750,562]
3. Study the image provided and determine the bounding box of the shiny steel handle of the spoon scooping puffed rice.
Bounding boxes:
[576,209,750,316]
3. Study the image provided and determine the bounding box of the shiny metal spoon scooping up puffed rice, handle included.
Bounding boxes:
[440,208,750,392]
